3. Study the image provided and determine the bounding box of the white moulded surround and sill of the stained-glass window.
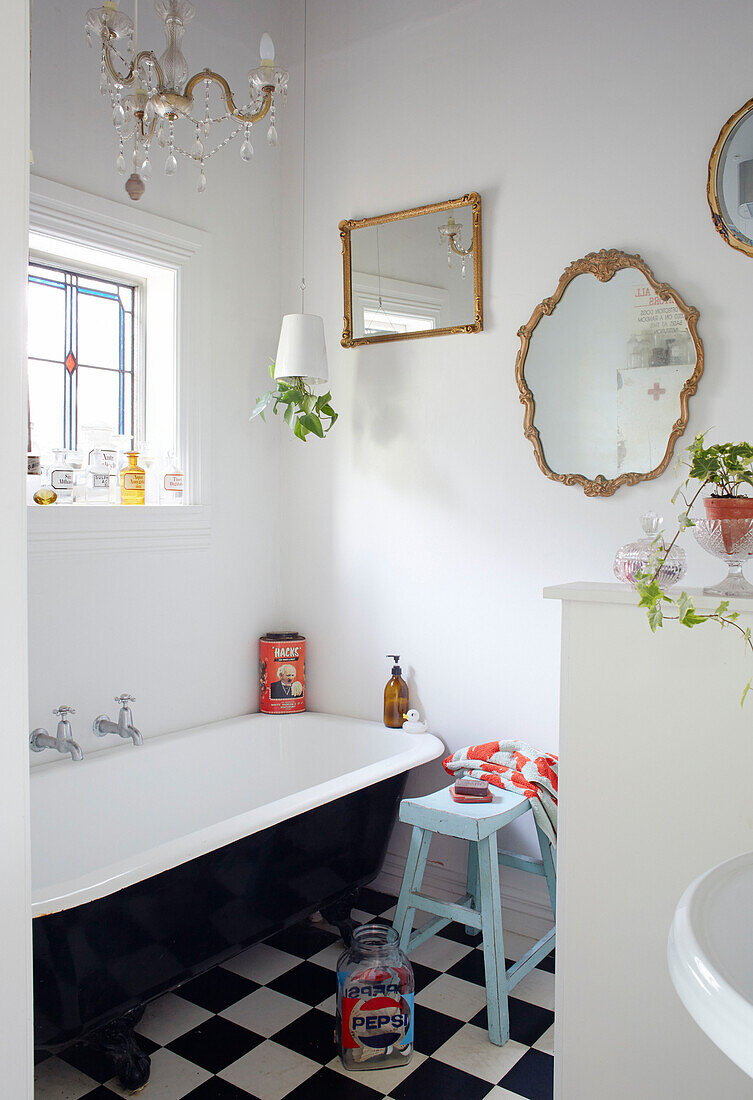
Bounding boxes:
[27,176,211,554]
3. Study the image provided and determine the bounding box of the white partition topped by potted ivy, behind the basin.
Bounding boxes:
[545,580,753,1100]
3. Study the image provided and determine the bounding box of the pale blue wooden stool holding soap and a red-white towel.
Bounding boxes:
[392,788,556,1046]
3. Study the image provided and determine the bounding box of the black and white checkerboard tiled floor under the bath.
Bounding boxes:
[34,890,554,1100]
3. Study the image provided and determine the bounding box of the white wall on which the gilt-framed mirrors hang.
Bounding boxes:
[281,0,753,884]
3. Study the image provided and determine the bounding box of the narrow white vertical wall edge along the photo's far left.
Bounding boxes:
[0,3,32,1100]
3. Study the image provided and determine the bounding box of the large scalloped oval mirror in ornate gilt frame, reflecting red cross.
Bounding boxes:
[516,249,704,496]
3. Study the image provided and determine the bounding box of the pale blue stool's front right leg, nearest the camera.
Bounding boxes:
[476,834,510,1046]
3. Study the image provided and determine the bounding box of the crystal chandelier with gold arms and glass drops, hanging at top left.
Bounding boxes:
[86,0,288,200]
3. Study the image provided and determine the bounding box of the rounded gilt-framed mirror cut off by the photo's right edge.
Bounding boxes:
[707,99,753,256]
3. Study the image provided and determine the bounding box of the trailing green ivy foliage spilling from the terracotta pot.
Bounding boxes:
[635,432,753,706]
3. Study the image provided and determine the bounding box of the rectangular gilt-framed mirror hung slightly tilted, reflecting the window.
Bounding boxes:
[340,191,484,348]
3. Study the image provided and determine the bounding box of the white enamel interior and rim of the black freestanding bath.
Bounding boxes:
[31,713,443,916]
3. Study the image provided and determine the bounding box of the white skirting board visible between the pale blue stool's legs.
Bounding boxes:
[370,850,553,939]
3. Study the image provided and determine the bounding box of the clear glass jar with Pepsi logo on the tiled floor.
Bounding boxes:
[335,923,414,1070]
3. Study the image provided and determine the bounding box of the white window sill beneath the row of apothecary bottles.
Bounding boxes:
[27,504,211,556]
